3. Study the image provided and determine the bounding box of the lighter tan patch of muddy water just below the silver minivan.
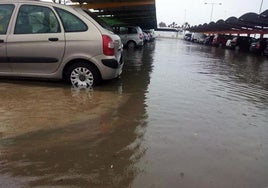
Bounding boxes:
[0,84,126,137]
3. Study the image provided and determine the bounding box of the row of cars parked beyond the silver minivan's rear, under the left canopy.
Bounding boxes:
[113,26,156,48]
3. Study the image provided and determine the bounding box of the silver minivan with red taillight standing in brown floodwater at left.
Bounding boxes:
[0,0,123,87]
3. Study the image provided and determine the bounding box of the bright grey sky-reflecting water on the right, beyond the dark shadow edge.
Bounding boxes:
[133,40,268,188]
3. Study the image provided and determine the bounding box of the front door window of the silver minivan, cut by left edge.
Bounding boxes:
[0,4,14,35]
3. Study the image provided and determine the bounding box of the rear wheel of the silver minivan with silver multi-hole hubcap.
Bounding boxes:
[66,62,101,88]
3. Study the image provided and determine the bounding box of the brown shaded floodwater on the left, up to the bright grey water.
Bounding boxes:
[0,42,152,187]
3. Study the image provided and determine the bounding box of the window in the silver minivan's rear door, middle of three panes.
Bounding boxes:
[14,5,60,34]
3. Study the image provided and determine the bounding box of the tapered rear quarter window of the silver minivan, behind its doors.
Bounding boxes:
[55,8,88,32]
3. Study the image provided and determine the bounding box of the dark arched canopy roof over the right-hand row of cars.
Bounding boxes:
[189,10,268,34]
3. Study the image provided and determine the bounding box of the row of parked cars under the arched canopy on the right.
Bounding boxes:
[184,33,268,56]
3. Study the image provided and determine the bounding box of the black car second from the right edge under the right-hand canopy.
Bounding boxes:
[230,36,256,51]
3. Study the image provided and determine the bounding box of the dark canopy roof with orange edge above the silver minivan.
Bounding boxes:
[72,0,157,29]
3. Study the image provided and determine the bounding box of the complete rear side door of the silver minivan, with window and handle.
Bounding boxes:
[7,4,65,76]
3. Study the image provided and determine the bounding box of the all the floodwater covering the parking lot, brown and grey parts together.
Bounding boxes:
[0,39,268,188]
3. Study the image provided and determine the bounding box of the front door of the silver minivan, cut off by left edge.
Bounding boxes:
[0,4,15,72]
